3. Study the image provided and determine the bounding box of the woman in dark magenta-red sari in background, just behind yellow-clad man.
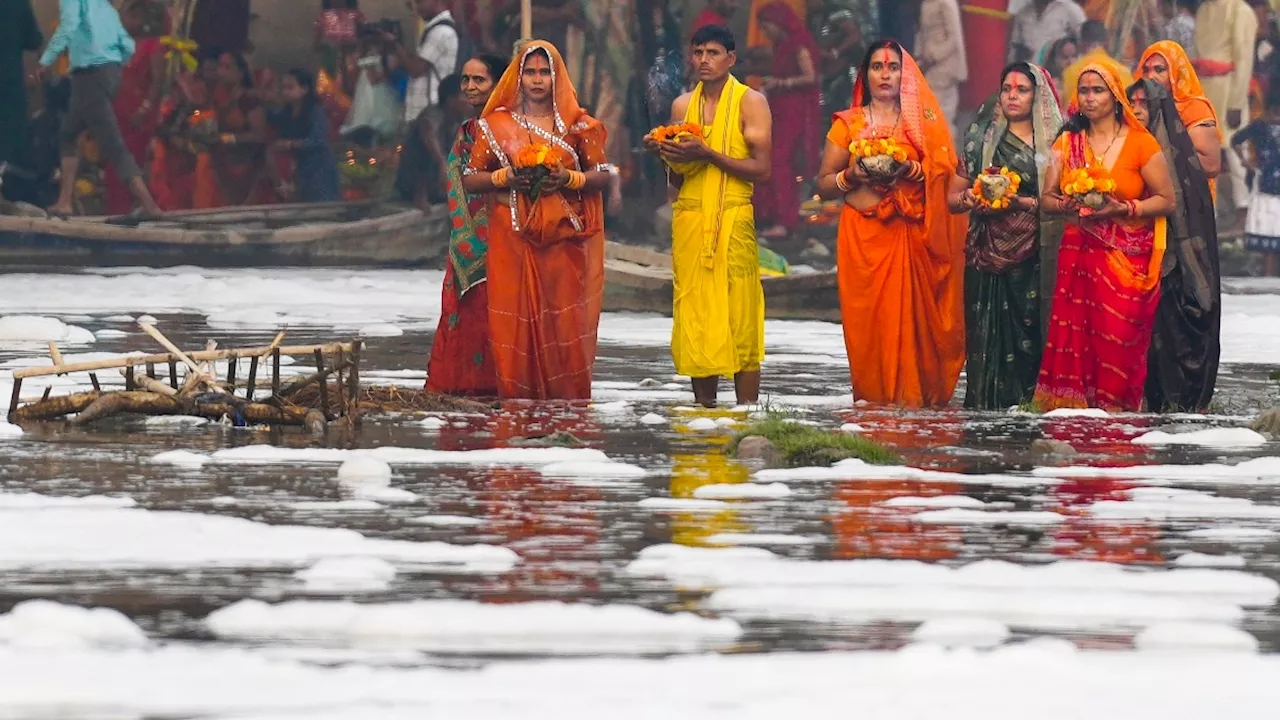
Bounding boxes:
[755,1,822,237]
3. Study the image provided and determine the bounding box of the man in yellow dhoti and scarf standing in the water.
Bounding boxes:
[646,26,773,407]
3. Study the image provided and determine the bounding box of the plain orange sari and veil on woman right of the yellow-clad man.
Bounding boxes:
[828,42,968,406]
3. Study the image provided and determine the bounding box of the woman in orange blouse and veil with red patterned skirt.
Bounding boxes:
[1036,59,1175,410]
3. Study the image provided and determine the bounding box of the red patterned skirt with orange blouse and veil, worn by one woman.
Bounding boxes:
[1036,61,1165,411]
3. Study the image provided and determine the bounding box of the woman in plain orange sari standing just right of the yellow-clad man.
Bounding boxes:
[818,41,968,407]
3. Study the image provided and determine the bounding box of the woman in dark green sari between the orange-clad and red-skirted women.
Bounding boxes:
[948,63,1062,410]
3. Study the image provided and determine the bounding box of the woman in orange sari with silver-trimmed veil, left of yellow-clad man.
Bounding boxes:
[462,41,611,400]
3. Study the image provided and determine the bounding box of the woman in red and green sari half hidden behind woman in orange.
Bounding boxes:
[426,55,507,397]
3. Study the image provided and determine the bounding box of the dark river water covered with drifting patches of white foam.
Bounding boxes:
[0,268,1280,720]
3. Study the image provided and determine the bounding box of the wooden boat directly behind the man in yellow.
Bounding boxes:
[604,242,840,323]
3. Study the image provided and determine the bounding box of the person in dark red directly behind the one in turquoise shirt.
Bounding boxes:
[106,0,169,215]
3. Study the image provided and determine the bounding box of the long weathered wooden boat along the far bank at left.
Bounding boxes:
[0,201,449,269]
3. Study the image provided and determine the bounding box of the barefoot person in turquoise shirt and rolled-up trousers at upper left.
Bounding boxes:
[40,0,161,217]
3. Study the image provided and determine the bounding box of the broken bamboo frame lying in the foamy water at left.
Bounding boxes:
[9,323,362,430]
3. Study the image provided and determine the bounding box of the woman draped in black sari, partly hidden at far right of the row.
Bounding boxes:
[1128,79,1222,413]
